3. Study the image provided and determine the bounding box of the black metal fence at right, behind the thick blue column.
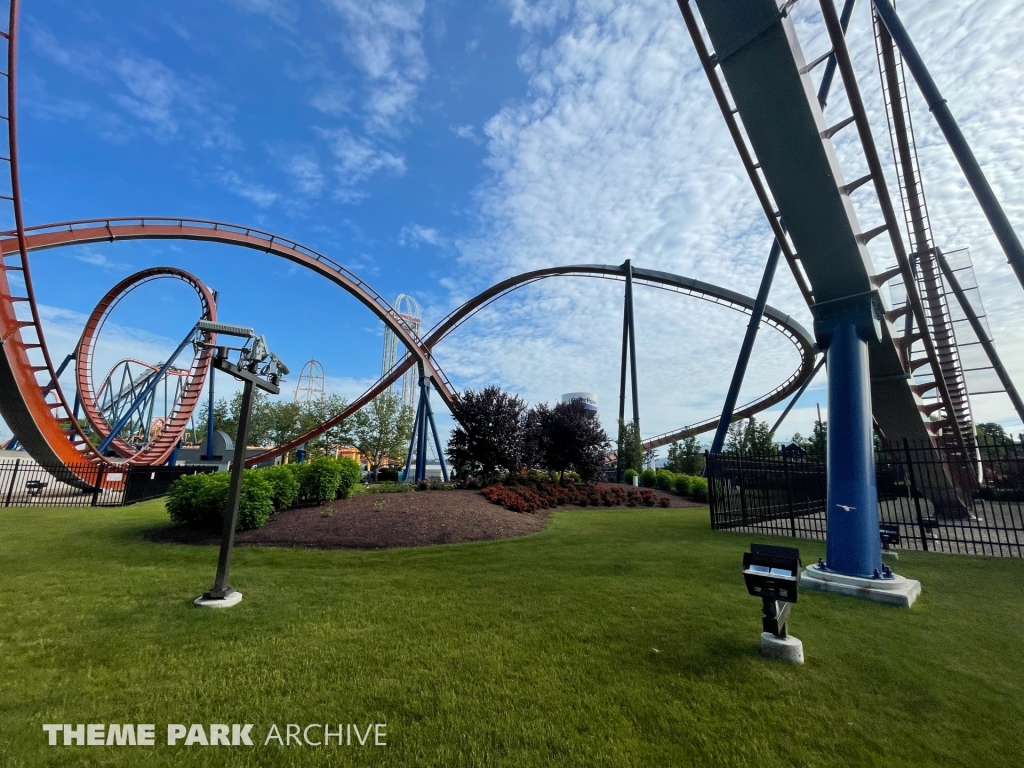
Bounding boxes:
[708,441,1024,557]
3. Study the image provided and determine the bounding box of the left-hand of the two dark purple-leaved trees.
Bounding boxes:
[446,386,536,477]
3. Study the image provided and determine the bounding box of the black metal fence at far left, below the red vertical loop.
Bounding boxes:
[0,459,216,507]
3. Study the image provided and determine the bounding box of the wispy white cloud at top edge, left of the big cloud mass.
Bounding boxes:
[331,0,429,132]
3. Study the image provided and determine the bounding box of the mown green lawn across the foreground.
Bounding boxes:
[0,503,1024,768]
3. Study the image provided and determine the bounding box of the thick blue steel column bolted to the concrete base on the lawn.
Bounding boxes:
[811,291,883,579]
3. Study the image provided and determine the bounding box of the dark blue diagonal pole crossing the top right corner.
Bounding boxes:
[872,0,1024,294]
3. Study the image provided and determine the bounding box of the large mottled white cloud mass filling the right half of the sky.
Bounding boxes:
[448,0,1024,444]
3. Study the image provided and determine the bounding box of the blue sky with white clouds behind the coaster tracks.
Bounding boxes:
[6,0,1024,450]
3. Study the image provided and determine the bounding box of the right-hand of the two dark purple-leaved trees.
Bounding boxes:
[543,399,611,482]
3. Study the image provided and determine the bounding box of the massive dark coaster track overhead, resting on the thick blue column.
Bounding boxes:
[677,0,966,462]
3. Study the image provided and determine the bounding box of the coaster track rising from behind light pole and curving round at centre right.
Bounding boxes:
[237,264,816,466]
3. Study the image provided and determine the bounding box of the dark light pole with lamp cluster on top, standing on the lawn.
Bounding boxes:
[195,321,288,608]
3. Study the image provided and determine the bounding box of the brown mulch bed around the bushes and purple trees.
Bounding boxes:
[145,483,701,549]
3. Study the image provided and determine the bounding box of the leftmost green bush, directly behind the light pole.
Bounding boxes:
[167,470,273,530]
